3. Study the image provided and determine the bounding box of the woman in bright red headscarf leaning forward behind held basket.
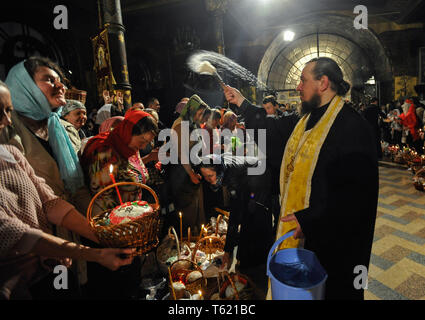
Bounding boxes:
[82,110,158,212]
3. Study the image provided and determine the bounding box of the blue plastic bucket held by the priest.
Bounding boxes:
[267,231,328,300]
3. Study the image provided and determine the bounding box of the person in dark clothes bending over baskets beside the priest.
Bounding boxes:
[195,154,273,296]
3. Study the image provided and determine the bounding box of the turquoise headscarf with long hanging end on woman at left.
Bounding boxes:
[5,61,84,193]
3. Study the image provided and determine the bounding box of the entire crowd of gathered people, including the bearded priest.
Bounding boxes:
[0,57,386,299]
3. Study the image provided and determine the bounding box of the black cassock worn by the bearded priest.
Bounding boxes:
[238,100,379,300]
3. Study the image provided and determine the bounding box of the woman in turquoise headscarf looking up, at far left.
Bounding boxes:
[0,57,90,283]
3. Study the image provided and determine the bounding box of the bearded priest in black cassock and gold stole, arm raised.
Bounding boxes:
[225,57,378,300]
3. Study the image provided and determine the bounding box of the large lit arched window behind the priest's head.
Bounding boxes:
[258,15,392,90]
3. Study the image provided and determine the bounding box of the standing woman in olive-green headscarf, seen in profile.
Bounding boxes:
[168,95,209,230]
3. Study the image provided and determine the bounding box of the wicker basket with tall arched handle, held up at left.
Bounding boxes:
[87,182,160,256]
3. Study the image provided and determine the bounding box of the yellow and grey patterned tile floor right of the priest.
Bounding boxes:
[365,162,425,300]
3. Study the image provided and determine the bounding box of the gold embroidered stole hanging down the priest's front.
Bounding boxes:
[276,96,344,249]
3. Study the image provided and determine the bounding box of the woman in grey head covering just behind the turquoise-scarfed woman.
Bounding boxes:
[60,100,87,154]
